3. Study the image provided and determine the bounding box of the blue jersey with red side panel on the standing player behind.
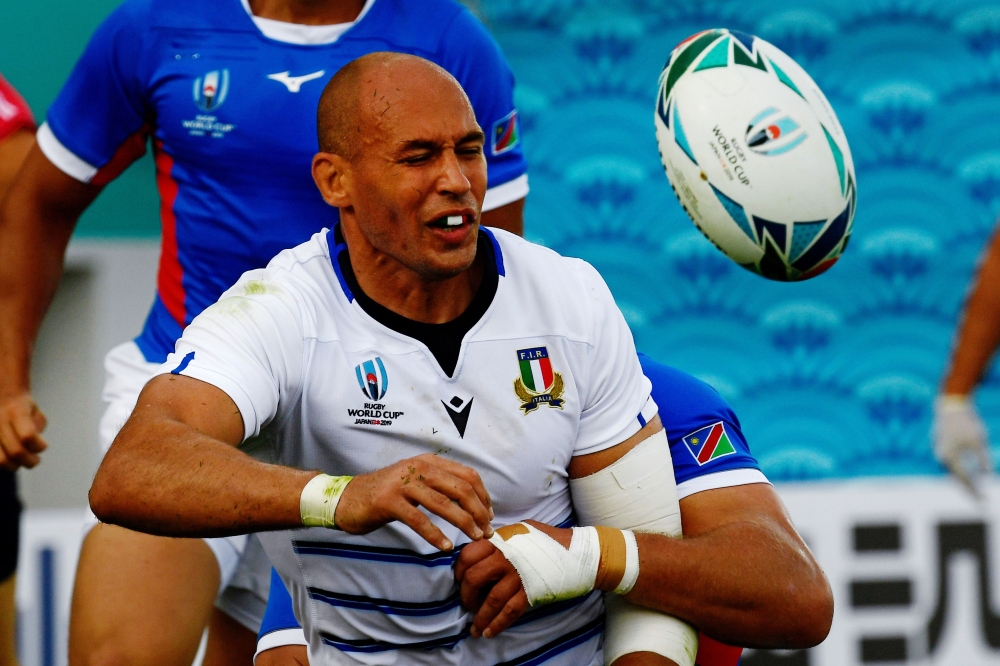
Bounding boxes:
[38,0,528,362]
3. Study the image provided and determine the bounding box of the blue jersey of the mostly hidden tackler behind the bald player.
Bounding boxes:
[257,353,767,666]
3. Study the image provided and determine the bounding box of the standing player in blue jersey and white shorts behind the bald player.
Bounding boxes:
[0,0,528,666]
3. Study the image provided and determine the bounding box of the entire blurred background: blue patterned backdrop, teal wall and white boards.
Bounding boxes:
[0,0,1000,666]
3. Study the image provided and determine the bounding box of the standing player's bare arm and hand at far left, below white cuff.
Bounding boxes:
[0,141,101,469]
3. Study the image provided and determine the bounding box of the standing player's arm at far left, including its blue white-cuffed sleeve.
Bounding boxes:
[0,6,157,469]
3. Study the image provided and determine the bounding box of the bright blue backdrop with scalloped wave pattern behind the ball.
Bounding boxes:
[473,0,1000,481]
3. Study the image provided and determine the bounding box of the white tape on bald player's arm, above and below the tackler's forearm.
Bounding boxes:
[569,430,698,666]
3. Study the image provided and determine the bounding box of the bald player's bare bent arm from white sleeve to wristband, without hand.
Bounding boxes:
[90,375,316,537]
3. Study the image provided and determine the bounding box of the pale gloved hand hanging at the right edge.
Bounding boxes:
[934,395,992,497]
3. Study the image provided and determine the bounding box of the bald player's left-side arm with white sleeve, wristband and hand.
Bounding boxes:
[90,271,492,550]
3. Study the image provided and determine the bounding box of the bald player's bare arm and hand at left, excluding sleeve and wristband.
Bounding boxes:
[90,374,493,550]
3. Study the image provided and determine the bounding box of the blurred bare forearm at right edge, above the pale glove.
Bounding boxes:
[943,224,1000,395]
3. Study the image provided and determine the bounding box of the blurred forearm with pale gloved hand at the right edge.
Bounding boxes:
[934,228,1000,495]
